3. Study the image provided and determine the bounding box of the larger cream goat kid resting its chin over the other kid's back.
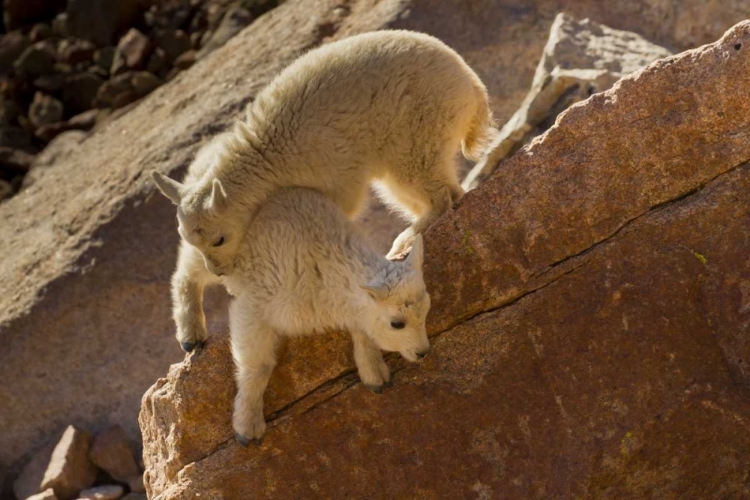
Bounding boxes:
[153,31,496,351]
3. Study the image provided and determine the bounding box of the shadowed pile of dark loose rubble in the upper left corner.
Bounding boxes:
[0,0,279,201]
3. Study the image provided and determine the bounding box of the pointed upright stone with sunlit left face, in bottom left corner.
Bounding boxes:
[41,425,96,500]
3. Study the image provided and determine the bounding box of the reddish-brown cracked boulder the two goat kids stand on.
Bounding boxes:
[140,22,750,500]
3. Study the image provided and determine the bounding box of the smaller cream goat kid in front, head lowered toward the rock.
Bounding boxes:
[222,188,430,446]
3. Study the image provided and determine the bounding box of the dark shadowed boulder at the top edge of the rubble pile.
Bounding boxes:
[66,0,139,47]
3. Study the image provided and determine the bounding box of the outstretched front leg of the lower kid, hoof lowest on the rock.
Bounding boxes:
[229,300,278,447]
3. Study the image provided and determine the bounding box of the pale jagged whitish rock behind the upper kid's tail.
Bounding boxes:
[462,14,671,190]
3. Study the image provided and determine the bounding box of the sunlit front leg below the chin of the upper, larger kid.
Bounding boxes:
[172,241,219,352]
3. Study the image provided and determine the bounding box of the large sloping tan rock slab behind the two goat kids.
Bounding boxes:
[0,0,750,480]
